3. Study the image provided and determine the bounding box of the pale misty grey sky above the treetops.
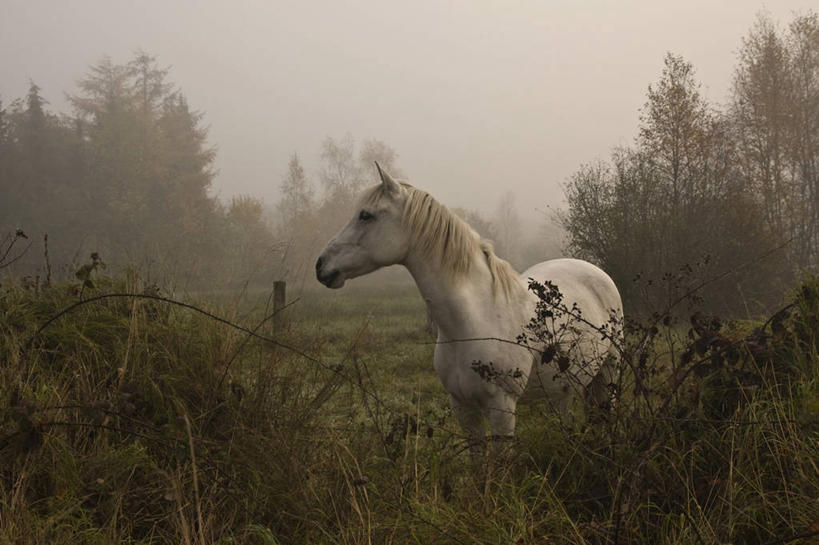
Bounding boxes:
[0,0,815,221]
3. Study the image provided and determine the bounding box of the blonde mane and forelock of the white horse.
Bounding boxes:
[362,182,519,298]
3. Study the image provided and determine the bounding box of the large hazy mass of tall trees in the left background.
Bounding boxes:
[0,52,272,284]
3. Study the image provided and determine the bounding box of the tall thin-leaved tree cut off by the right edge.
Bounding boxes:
[731,12,819,268]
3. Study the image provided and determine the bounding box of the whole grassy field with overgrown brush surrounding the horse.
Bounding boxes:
[0,275,819,544]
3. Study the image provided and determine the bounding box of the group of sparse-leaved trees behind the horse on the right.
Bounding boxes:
[559,12,819,313]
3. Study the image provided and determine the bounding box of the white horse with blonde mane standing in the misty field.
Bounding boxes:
[316,163,622,442]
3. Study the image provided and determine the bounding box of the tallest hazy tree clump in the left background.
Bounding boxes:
[65,51,219,267]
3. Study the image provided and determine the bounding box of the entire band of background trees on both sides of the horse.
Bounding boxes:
[0,12,819,314]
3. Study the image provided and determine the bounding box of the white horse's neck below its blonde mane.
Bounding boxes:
[404,244,496,339]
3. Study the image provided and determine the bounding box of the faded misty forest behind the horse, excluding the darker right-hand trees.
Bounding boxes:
[0,52,540,287]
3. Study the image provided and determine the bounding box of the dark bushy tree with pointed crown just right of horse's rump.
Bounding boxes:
[560,54,772,310]
